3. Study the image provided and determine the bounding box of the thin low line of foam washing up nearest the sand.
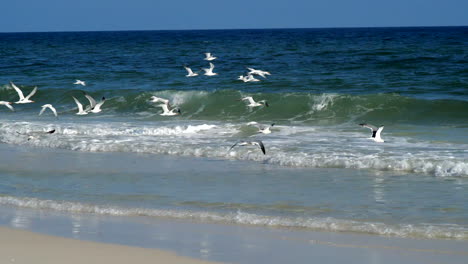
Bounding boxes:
[0,196,468,240]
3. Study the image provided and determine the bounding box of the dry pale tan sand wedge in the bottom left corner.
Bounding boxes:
[0,227,220,264]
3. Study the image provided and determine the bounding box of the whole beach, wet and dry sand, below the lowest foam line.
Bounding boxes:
[0,206,468,264]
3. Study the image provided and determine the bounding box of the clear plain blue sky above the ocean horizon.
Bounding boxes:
[0,0,468,32]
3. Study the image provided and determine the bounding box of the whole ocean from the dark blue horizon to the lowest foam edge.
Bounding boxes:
[0,27,468,243]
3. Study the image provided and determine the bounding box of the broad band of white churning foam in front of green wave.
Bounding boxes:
[0,122,468,177]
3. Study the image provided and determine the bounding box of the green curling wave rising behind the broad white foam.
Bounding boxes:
[0,87,468,124]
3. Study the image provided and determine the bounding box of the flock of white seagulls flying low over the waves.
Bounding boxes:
[0,53,385,155]
